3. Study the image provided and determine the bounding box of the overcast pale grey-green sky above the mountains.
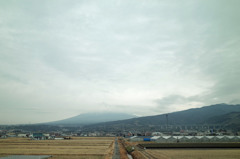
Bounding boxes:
[0,0,240,124]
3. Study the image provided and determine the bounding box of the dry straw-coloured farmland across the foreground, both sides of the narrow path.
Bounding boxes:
[0,137,240,159]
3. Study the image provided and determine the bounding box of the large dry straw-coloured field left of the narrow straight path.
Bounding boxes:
[0,137,114,159]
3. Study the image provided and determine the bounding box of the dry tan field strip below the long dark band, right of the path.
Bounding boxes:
[143,149,240,159]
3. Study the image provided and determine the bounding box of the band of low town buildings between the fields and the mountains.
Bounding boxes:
[0,125,240,140]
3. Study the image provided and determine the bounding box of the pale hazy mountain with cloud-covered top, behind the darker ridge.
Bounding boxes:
[45,112,136,126]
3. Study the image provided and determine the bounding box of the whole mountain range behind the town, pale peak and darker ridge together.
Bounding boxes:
[5,104,240,134]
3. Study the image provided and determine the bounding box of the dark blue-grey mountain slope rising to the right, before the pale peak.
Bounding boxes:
[81,104,240,131]
